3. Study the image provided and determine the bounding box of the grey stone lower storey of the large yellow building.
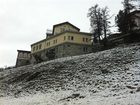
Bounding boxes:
[31,43,92,63]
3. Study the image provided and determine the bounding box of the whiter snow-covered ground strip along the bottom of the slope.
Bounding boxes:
[0,91,140,105]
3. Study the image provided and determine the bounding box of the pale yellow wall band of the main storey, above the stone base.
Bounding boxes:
[31,32,92,53]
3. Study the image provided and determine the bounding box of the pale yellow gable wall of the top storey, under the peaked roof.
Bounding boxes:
[54,24,78,35]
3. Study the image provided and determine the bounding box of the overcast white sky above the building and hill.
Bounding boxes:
[0,0,122,67]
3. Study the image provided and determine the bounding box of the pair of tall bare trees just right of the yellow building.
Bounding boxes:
[88,4,110,43]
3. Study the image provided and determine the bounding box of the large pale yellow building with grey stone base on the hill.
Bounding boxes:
[31,22,92,63]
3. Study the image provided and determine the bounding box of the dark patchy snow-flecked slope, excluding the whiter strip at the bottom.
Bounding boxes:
[0,44,140,104]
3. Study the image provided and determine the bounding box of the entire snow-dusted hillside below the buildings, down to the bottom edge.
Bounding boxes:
[0,43,140,105]
